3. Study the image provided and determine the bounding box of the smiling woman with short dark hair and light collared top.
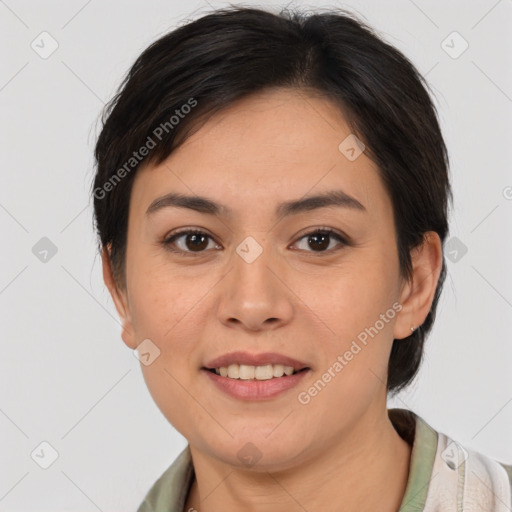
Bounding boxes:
[93,8,512,512]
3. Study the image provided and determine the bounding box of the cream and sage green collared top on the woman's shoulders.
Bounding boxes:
[137,408,512,512]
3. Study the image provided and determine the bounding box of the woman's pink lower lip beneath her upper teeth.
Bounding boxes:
[201,368,310,400]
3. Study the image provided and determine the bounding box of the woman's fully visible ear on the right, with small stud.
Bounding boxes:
[393,231,443,339]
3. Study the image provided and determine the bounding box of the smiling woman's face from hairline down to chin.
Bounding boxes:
[109,90,423,469]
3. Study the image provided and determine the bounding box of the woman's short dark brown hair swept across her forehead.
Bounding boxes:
[92,6,453,393]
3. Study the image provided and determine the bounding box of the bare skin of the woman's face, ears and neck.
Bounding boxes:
[103,89,442,512]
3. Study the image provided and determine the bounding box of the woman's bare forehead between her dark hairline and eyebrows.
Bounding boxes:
[132,89,390,222]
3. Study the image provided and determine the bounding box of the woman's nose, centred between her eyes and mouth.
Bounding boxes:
[218,238,294,331]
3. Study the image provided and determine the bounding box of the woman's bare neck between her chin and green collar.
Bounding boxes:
[185,411,411,512]
